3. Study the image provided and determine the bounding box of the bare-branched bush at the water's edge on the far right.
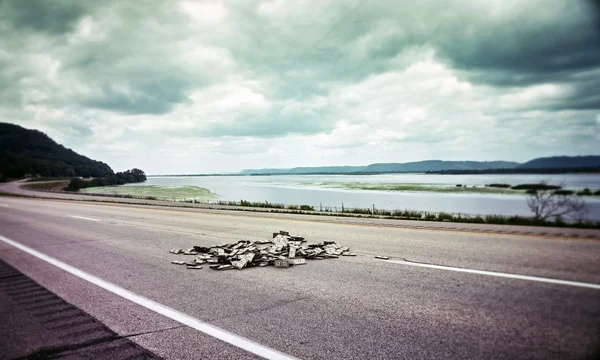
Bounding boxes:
[527,182,589,221]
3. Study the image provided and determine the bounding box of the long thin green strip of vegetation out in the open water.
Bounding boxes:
[302,182,525,194]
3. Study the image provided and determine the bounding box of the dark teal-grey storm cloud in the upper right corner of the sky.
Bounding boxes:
[439,1,600,78]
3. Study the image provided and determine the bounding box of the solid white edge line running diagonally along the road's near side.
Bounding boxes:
[0,235,296,360]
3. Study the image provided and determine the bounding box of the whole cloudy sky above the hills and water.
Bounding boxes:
[0,0,600,174]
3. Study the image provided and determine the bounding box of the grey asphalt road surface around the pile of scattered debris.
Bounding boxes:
[0,197,600,359]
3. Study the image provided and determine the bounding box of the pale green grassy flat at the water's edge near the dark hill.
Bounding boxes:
[79,185,216,201]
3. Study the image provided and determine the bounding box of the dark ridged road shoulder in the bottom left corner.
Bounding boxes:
[0,260,160,359]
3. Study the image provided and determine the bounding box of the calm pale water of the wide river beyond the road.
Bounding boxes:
[137,174,600,220]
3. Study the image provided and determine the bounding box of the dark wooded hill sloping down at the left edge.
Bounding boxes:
[0,123,114,178]
